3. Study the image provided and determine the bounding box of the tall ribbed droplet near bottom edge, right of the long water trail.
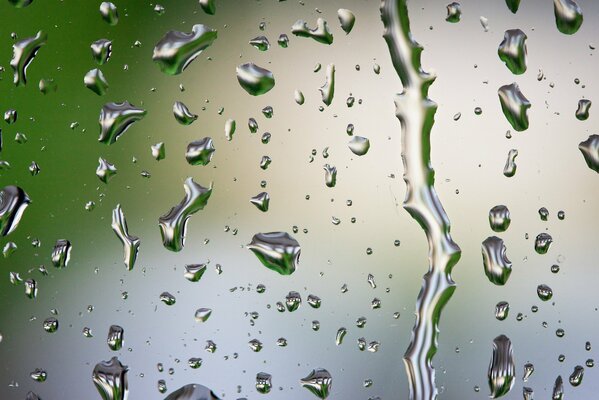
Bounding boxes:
[488,335,516,399]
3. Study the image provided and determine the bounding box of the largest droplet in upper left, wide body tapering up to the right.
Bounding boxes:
[152,24,217,75]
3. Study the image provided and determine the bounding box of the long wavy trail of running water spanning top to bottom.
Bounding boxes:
[381,0,461,400]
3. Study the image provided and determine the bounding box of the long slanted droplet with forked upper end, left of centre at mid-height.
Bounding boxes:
[158,177,212,251]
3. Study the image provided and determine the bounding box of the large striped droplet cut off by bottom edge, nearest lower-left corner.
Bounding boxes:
[92,357,129,400]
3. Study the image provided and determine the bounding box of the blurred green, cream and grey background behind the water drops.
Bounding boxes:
[0,0,599,399]
